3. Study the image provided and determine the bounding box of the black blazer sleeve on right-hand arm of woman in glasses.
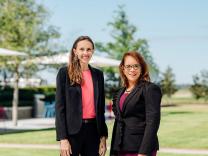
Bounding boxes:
[139,83,162,154]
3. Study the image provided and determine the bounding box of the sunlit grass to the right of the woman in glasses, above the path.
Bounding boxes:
[159,105,208,149]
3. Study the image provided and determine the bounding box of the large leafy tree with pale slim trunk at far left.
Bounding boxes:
[0,0,60,125]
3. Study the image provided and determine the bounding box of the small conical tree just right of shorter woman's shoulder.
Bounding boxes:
[160,67,177,103]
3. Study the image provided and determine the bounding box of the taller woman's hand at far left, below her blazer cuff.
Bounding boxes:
[60,139,72,156]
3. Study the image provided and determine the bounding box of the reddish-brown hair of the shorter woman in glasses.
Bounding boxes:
[119,51,150,87]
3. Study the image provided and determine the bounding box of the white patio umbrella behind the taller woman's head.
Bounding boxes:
[23,53,120,67]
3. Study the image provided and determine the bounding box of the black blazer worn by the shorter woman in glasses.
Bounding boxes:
[111,81,162,155]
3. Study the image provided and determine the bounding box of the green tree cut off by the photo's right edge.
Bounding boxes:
[190,70,208,100]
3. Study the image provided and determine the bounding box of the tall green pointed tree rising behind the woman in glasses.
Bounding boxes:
[96,6,159,98]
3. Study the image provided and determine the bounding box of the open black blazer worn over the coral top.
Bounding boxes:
[56,66,108,140]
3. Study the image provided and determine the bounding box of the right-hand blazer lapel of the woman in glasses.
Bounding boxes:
[119,81,143,113]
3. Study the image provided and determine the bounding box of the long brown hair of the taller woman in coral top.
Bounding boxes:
[68,36,95,85]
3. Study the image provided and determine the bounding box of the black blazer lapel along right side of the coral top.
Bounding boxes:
[89,65,98,112]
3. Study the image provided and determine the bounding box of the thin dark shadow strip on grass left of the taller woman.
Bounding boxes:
[0,128,55,135]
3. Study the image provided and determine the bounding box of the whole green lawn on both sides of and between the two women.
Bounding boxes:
[0,104,208,152]
